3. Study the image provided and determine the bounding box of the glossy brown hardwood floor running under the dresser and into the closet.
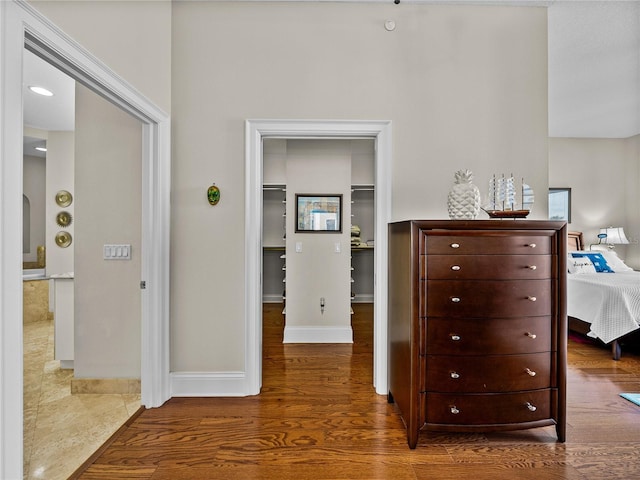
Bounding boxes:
[77,304,640,480]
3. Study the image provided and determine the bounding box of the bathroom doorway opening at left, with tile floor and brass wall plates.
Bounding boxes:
[23,50,142,478]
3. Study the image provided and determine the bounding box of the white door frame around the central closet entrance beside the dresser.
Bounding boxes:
[245,120,391,395]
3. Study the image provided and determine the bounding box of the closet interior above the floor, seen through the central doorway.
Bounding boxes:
[262,138,375,343]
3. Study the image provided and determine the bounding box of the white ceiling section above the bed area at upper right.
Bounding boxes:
[548,1,640,138]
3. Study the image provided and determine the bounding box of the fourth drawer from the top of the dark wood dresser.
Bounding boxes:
[420,316,552,355]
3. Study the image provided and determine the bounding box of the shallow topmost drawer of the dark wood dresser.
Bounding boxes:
[424,234,553,255]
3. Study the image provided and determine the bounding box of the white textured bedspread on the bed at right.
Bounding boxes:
[567,272,640,343]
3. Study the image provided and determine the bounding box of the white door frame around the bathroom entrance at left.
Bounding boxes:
[0,0,171,479]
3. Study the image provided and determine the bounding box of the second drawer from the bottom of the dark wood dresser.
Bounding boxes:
[426,352,552,393]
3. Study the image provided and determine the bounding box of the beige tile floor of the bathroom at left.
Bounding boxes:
[23,280,140,480]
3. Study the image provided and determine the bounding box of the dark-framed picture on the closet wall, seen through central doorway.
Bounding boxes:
[296,193,342,233]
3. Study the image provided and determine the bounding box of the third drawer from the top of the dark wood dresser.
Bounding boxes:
[420,280,553,318]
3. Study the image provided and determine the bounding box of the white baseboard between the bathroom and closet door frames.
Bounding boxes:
[169,372,248,397]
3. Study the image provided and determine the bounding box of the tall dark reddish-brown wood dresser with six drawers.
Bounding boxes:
[389,220,567,448]
